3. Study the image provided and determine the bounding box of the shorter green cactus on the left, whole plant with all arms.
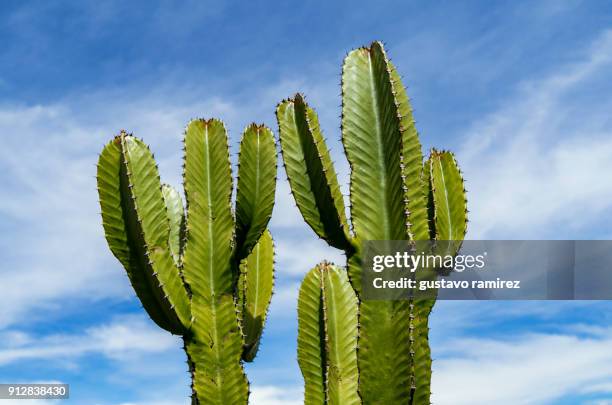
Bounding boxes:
[97,119,277,404]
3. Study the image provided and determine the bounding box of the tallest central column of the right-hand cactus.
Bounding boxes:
[342,42,412,404]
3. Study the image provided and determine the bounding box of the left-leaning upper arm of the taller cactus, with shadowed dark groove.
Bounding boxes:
[276,94,351,250]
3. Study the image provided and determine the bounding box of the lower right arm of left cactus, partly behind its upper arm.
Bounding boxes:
[239,230,274,362]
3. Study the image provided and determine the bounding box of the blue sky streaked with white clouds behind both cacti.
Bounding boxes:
[0,0,612,405]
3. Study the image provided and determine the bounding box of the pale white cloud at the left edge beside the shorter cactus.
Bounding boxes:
[0,106,125,325]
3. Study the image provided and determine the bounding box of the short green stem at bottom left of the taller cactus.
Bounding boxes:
[298,262,361,405]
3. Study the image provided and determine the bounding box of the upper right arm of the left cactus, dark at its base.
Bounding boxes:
[236,124,277,260]
